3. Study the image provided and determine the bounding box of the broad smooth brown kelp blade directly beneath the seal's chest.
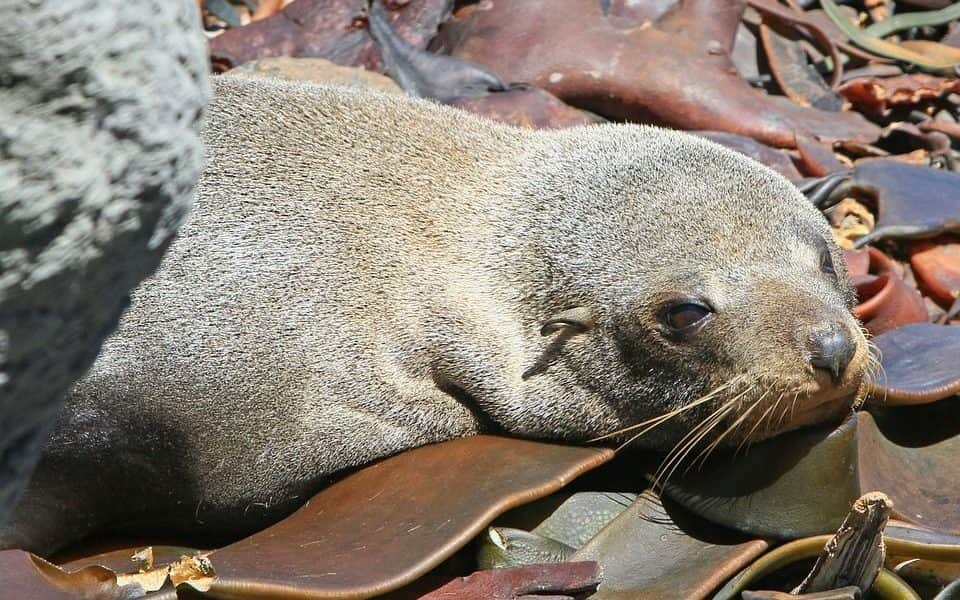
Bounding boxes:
[172,436,612,599]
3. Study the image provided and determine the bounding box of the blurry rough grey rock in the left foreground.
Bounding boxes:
[0,0,209,522]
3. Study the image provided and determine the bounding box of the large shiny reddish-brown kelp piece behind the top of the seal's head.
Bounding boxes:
[439,0,879,147]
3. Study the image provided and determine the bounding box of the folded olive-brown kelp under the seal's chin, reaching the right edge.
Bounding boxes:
[666,408,960,539]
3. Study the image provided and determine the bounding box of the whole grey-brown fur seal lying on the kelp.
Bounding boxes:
[0,77,868,553]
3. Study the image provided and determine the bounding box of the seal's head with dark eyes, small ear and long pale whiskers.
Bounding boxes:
[516,127,869,447]
